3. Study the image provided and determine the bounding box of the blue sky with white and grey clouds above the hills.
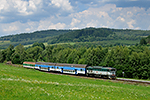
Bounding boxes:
[0,0,150,37]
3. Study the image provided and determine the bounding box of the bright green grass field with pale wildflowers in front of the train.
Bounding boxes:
[0,64,150,100]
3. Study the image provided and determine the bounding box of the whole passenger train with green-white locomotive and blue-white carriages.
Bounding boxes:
[23,62,116,79]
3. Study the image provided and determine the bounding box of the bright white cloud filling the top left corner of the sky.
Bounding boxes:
[0,0,42,16]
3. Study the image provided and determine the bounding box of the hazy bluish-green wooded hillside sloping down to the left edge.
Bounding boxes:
[0,30,72,49]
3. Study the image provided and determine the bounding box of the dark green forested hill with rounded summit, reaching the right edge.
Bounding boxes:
[48,28,150,45]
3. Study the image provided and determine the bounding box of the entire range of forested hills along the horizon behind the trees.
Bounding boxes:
[0,27,150,49]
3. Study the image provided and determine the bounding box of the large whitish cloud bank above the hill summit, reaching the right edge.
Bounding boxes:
[67,4,150,29]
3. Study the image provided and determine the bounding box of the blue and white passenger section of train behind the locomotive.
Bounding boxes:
[35,62,87,74]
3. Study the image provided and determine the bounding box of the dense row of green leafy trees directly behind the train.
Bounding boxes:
[0,43,150,79]
